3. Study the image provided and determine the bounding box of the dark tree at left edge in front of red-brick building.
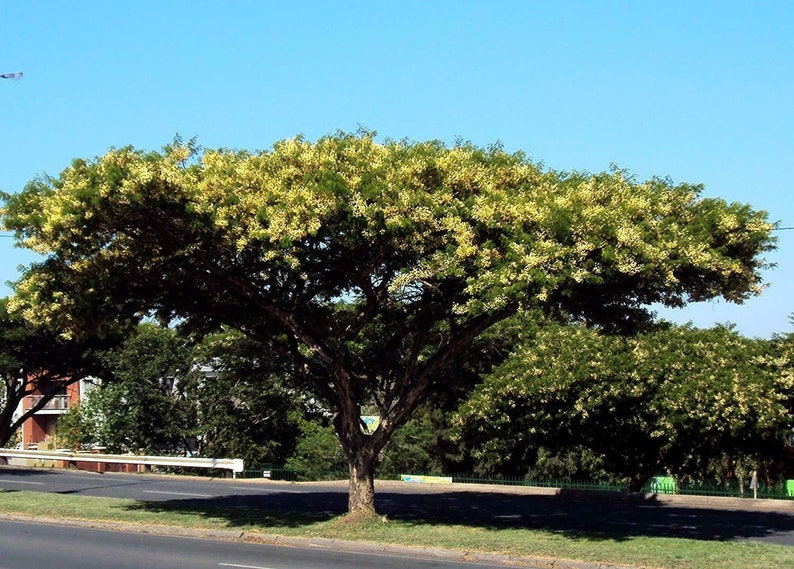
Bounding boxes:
[0,298,104,447]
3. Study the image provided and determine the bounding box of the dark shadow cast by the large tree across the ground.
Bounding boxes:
[120,489,794,545]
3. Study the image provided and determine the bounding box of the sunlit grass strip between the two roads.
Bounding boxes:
[0,490,794,569]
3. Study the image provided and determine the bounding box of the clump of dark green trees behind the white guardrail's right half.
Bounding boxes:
[69,323,315,464]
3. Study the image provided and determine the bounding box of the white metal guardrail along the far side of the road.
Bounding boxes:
[0,448,244,474]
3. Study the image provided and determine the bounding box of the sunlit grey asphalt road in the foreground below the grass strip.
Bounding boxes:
[0,521,503,569]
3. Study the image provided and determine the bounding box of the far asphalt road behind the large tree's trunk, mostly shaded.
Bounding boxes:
[0,467,794,546]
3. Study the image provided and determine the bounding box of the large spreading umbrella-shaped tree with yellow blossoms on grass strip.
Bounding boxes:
[3,133,772,513]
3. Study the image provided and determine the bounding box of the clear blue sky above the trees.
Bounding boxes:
[0,0,794,337]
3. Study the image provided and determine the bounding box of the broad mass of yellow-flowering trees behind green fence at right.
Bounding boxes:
[456,325,792,491]
